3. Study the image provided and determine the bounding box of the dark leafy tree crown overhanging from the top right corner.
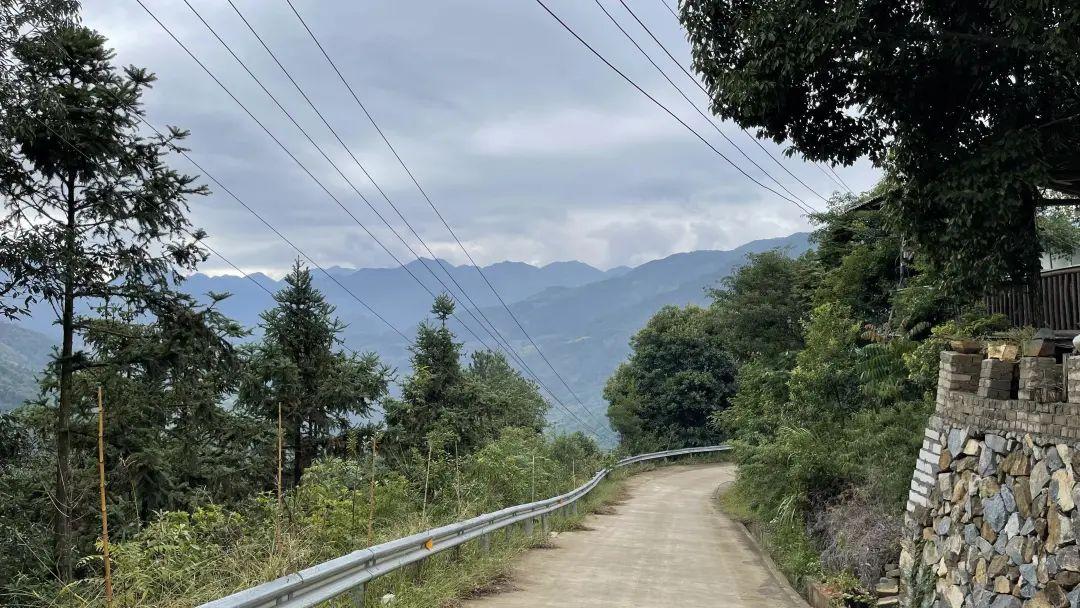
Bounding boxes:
[681,0,1080,293]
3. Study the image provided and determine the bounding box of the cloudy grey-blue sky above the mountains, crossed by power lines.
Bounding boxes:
[83,0,878,276]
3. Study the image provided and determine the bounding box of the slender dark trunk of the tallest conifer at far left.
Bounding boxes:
[55,175,76,582]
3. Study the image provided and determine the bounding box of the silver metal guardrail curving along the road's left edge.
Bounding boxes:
[199,445,730,608]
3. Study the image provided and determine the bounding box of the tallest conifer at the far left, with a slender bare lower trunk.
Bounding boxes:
[0,22,205,580]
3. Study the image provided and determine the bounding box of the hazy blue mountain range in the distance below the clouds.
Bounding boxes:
[0,232,810,430]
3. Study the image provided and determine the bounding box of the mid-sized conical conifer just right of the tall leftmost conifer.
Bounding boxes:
[239,260,390,486]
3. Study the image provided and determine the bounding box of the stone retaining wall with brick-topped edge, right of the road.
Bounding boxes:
[901,352,1080,608]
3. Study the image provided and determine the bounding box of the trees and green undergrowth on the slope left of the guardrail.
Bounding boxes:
[0,0,604,606]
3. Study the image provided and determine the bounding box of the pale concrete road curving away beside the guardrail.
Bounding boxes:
[464,464,807,608]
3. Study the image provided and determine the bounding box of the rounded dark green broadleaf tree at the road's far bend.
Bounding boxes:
[604,306,735,448]
